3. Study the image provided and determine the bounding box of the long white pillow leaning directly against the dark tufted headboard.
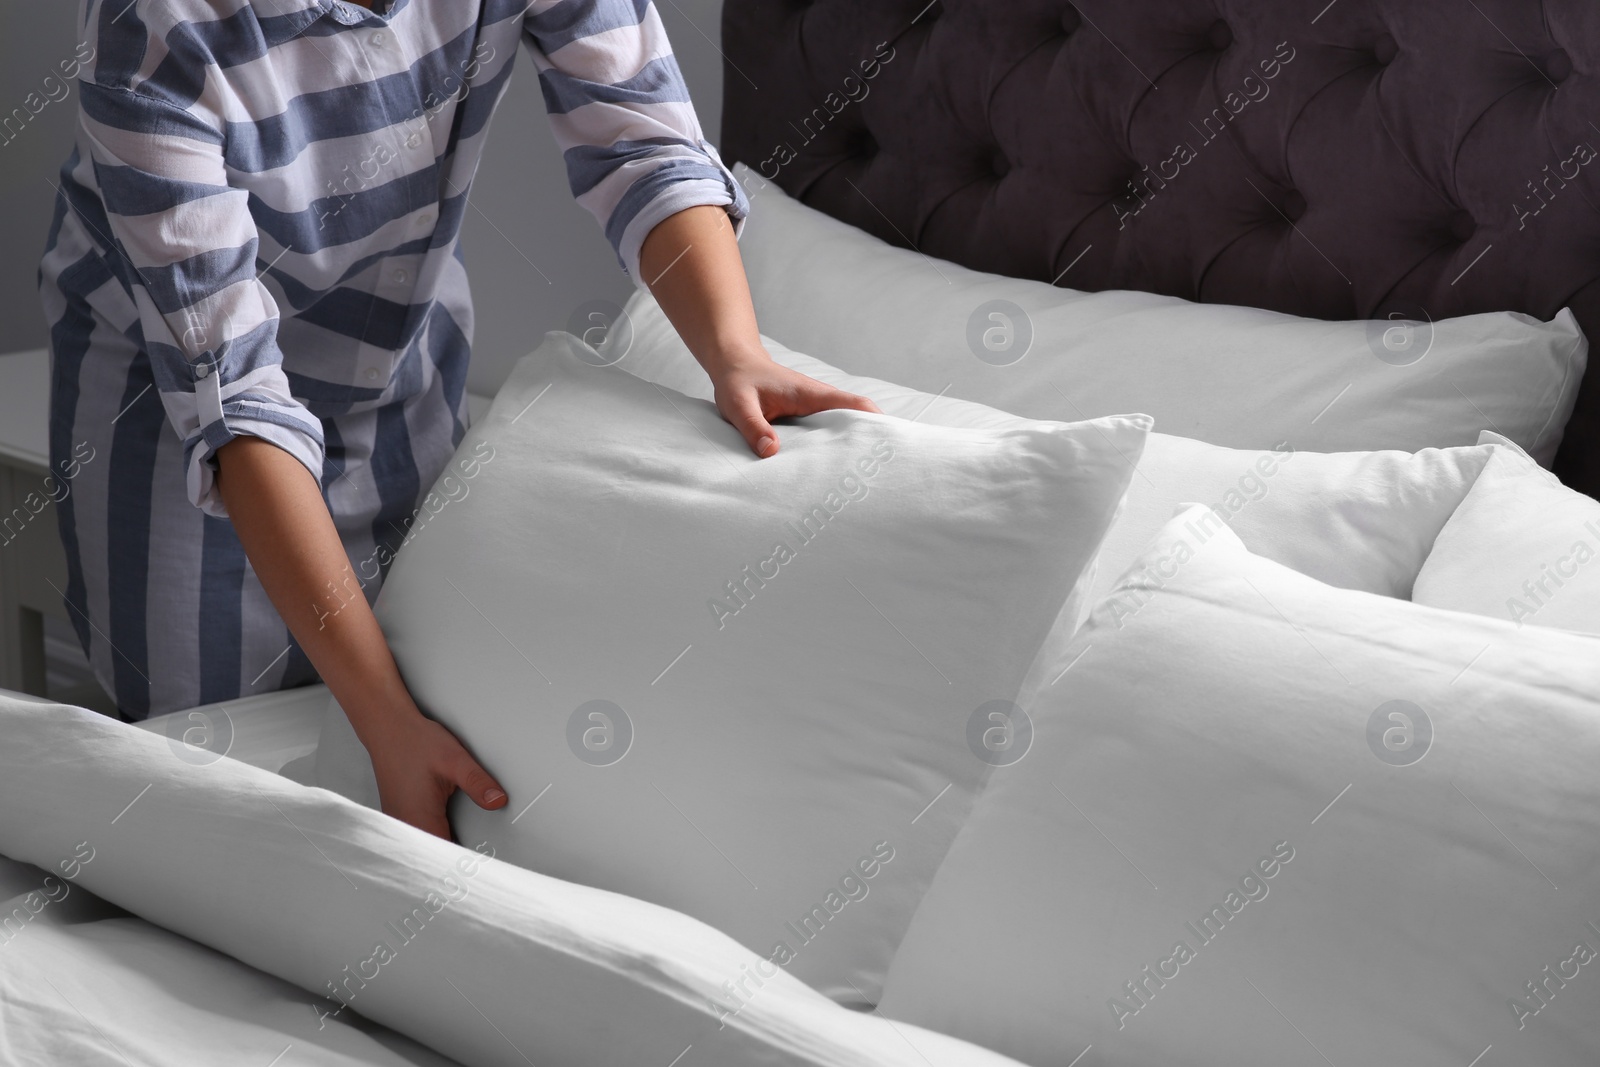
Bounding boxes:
[736,159,1587,464]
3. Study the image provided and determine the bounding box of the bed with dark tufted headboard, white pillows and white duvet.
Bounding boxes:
[0,0,1600,1067]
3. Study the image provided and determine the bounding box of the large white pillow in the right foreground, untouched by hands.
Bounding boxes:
[882,509,1600,1067]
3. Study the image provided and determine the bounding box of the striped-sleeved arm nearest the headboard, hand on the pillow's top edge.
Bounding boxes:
[525,0,877,456]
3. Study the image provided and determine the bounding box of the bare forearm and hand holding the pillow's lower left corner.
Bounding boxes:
[216,437,507,838]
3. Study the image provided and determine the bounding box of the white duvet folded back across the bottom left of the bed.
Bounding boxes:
[0,696,1014,1067]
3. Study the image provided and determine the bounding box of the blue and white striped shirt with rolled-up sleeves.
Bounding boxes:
[40,0,749,718]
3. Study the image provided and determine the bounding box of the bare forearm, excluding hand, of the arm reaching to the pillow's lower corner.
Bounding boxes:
[218,437,419,750]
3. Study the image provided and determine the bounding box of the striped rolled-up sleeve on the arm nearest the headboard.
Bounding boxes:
[525,0,750,290]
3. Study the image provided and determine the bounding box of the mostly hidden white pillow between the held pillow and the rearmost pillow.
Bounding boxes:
[600,291,1504,617]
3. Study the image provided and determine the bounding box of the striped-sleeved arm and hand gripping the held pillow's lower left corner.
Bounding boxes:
[64,12,506,837]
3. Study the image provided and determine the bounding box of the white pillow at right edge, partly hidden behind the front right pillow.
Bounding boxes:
[1416,434,1600,633]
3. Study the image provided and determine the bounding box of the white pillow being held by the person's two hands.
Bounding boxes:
[323,333,1149,1005]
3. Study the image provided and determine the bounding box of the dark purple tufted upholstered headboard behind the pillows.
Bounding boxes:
[722,0,1600,496]
